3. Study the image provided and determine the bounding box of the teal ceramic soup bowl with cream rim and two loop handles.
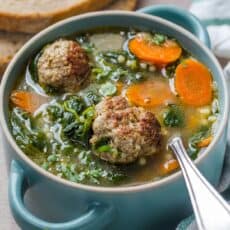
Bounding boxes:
[0,6,229,230]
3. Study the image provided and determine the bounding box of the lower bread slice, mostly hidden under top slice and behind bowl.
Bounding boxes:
[0,0,137,76]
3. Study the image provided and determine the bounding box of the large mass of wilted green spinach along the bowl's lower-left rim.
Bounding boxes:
[10,103,126,185]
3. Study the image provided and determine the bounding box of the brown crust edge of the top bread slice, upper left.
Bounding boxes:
[0,0,112,33]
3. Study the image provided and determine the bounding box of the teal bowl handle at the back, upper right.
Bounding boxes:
[138,5,211,48]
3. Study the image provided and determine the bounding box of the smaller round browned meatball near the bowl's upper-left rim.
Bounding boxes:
[37,39,90,92]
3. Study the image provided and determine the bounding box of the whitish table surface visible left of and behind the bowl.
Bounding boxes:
[0,0,190,230]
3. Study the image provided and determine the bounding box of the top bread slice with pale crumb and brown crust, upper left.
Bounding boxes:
[0,0,112,33]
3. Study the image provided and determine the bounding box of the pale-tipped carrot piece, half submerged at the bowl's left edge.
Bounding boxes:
[10,90,48,113]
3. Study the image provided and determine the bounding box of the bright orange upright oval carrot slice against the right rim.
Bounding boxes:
[175,58,212,106]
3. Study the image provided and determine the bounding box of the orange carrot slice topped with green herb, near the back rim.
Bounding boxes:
[129,36,182,65]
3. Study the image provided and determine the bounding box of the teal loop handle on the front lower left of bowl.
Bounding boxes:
[9,161,114,230]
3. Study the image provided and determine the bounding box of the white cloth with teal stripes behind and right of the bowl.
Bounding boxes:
[176,0,230,230]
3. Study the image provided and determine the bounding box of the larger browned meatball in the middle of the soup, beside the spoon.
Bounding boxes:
[90,96,162,164]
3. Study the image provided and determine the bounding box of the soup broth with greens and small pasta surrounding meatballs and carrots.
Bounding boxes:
[10,28,219,186]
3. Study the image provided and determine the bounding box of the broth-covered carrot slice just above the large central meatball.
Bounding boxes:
[126,79,176,108]
